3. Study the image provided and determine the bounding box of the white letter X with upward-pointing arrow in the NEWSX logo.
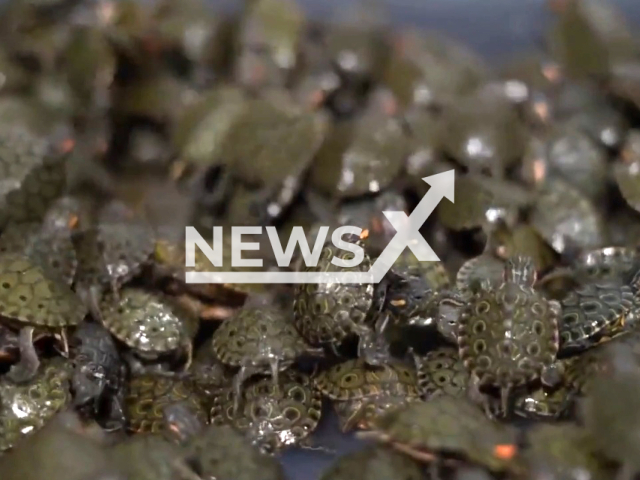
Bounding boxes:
[369,170,455,283]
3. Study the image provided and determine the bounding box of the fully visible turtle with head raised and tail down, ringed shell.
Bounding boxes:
[458,256,561,415]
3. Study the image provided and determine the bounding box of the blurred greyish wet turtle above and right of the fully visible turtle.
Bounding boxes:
[530,179,606,255]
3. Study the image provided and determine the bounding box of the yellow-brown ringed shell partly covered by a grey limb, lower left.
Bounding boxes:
[124,375,207,433]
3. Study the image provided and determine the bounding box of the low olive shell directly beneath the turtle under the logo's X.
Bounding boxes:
[314,359,418,401]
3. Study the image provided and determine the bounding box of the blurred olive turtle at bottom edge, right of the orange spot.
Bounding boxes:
[517,423,611,480]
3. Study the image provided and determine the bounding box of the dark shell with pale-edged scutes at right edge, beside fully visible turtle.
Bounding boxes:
[559,281,639,353]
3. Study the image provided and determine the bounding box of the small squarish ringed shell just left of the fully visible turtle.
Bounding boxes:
[415,347,469,400]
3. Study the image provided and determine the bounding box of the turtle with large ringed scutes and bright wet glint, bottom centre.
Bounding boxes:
[211,370,322,453]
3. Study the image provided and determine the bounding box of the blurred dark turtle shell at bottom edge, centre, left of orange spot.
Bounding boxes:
[320,445,424,480]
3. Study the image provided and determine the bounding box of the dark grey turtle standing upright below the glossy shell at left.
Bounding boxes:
[70,322,127,430]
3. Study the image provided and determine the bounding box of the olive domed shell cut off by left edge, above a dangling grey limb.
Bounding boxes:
[0,253,87,329]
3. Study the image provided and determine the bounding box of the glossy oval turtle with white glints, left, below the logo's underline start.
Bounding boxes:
[100,287,198,370]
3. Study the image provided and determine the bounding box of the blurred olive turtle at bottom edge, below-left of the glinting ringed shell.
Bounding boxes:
[185,425,285,480]
